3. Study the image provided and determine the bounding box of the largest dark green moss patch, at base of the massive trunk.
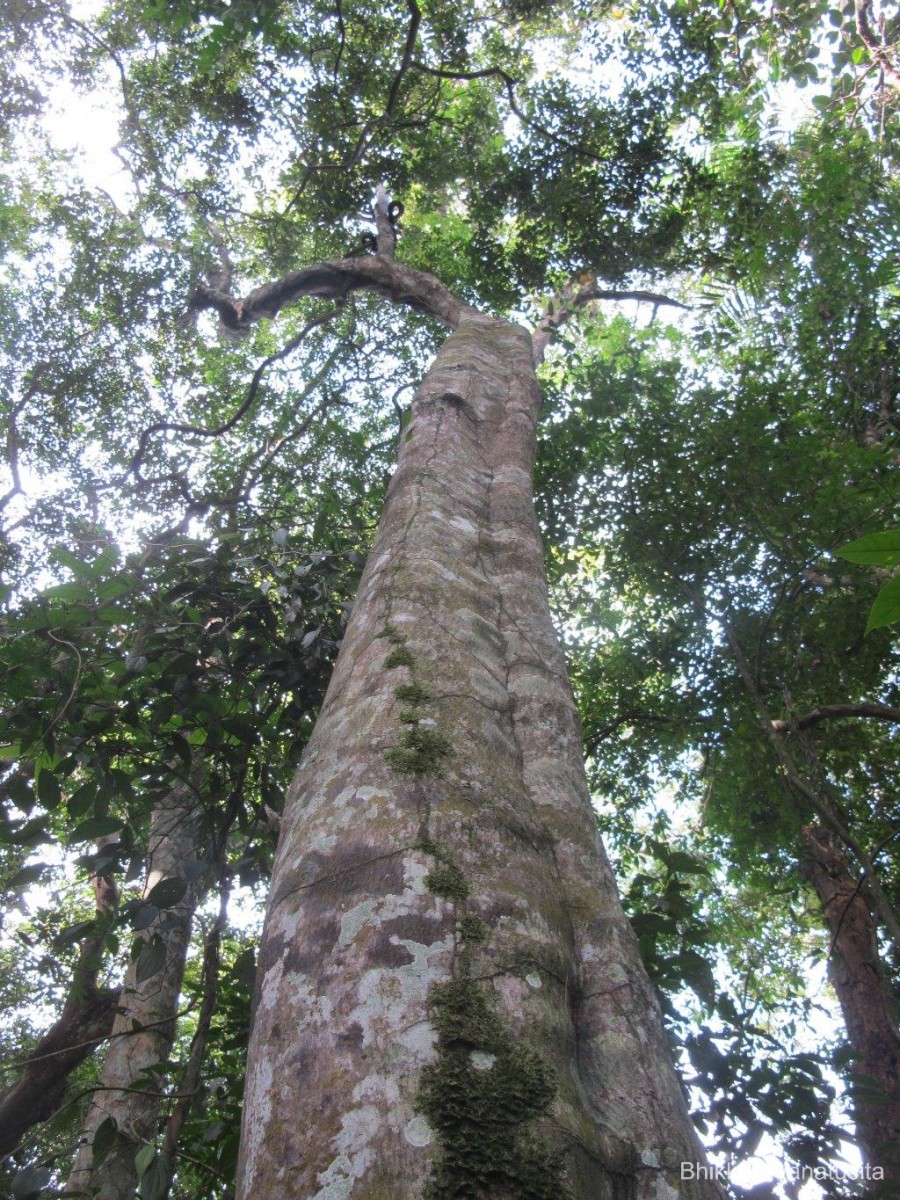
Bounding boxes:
[419,978,568,1200]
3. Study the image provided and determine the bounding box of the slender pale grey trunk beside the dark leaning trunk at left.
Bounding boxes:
[66,786,197,1200]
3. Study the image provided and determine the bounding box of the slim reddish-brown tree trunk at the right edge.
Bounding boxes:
[803,824,900,1183]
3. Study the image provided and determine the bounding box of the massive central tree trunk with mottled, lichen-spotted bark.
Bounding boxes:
[238,312,718,1200]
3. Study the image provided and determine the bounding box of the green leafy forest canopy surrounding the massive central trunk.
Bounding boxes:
[0,0,900,1200]
